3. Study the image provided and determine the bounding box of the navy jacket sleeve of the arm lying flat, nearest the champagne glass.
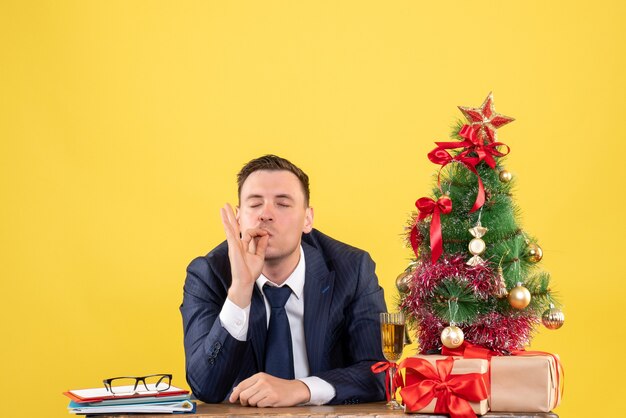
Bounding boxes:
[317,253,387,404]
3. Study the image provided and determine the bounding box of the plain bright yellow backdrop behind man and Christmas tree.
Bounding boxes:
[0,0,626,417]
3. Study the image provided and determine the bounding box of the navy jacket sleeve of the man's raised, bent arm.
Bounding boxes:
[180,257,249,403]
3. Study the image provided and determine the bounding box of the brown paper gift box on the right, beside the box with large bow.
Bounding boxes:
[490,355,562,412]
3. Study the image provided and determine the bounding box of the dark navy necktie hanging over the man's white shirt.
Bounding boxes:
[263,284,294,379]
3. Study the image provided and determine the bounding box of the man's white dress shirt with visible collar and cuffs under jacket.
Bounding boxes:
[219,246,335,405]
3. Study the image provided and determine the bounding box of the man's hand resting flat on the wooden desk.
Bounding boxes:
[228,373,311,408]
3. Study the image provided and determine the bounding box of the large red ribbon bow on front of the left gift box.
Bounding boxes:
[396,357,487,418]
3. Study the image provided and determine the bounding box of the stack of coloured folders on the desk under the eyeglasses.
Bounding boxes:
[64,386,196,415]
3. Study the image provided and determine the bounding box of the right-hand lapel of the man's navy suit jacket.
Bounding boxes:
[302,242,335,374]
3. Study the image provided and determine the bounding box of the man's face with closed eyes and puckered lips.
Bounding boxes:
[237,170,313,262]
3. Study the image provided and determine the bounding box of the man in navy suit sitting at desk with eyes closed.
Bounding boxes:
[180,155,386,407]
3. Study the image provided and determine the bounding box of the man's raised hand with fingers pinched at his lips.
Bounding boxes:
[220,204,269,308]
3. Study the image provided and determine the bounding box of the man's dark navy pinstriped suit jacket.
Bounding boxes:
[180,229,387,404]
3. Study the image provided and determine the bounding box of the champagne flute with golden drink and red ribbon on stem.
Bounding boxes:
[380,312,404,409]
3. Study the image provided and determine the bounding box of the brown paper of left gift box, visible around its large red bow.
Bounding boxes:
[400,355,489,415]
